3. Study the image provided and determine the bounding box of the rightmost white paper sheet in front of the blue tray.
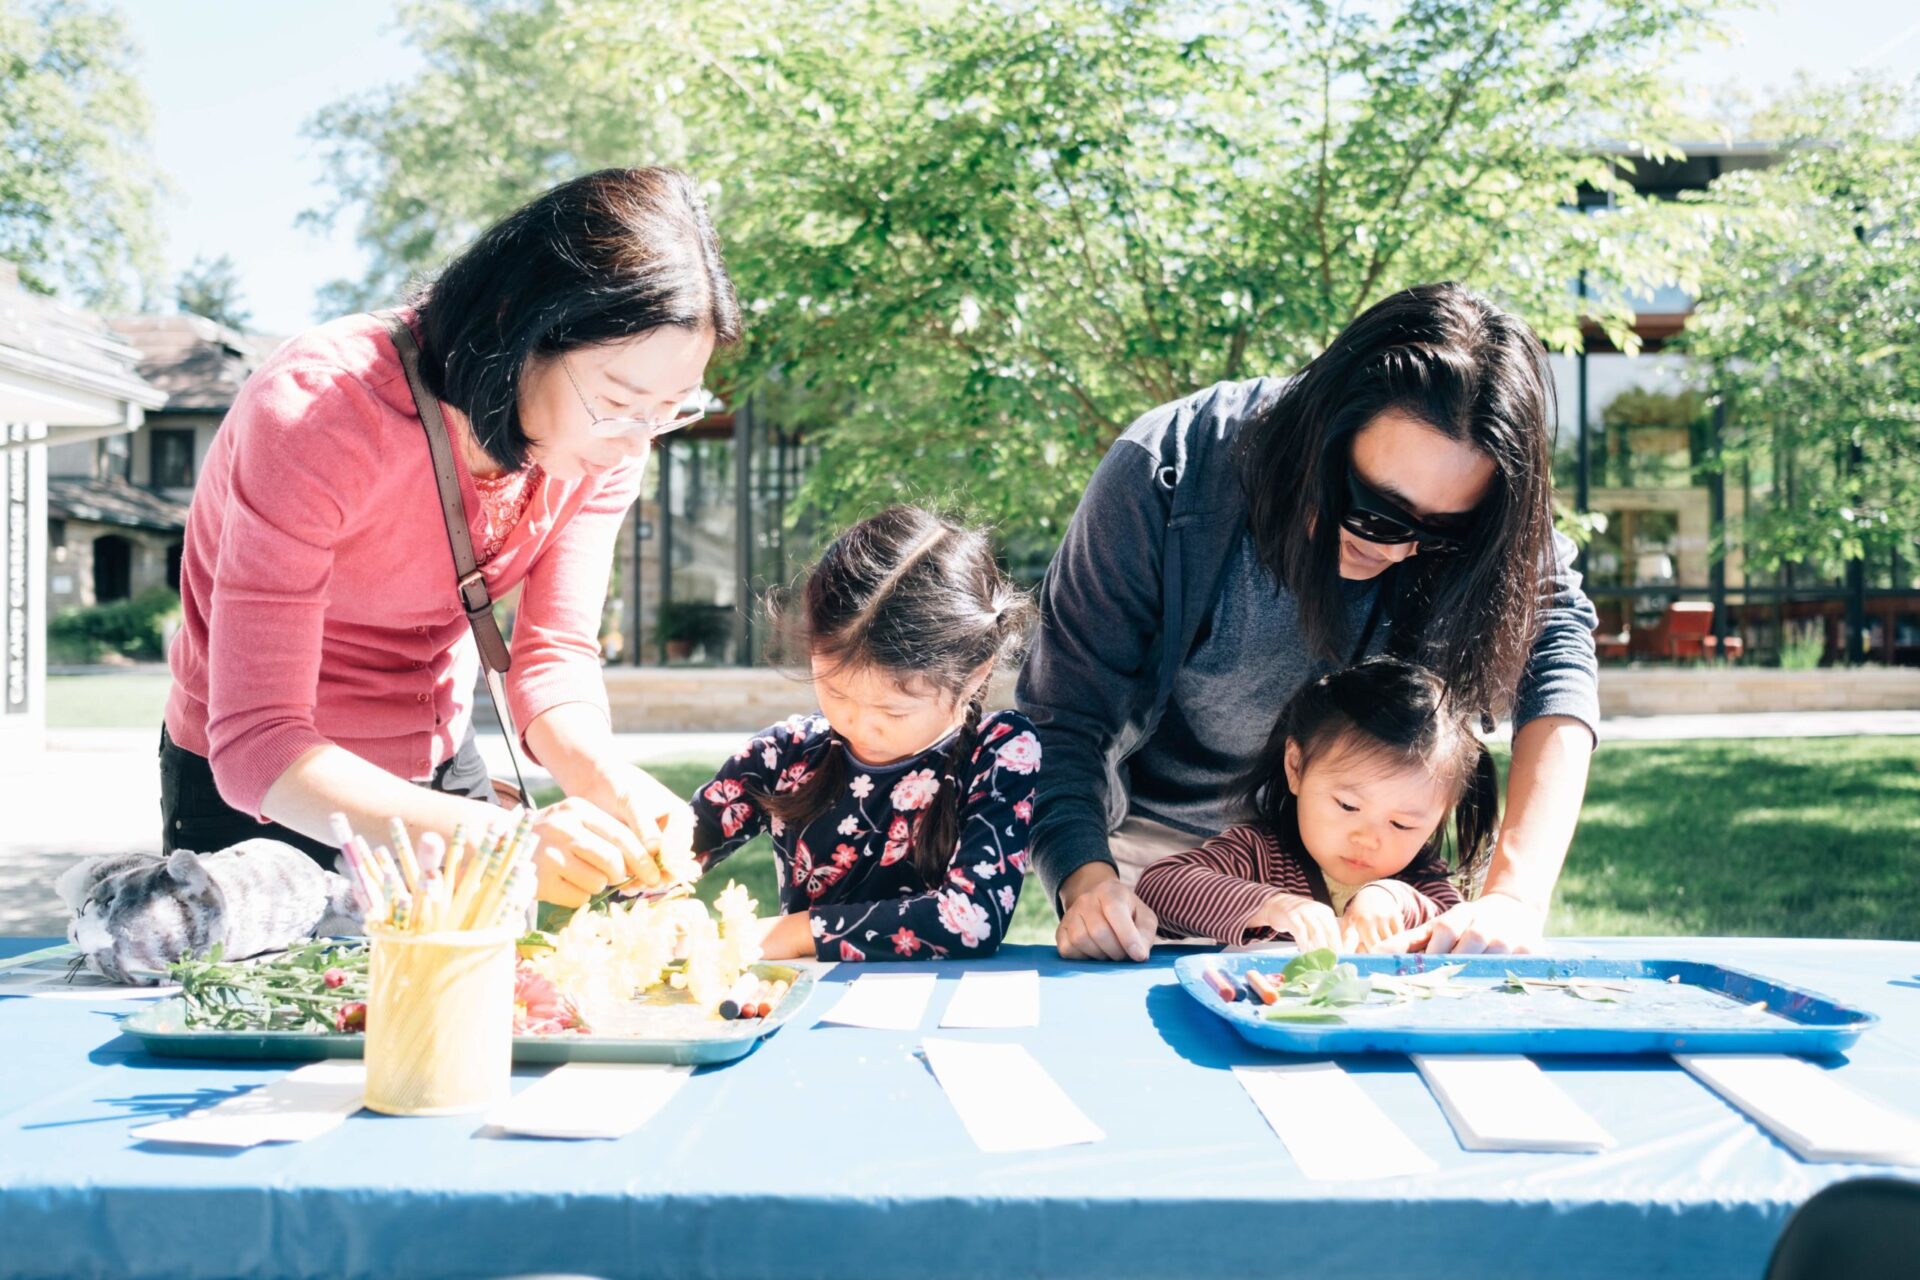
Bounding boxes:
[1674,1054,1920,1165]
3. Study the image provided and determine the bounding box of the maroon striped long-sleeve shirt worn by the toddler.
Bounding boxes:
[1135,825,1459,946]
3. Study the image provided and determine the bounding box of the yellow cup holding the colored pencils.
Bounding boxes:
[367,929,515,1115]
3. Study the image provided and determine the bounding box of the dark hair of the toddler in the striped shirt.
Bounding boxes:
[1238,656,1500,887]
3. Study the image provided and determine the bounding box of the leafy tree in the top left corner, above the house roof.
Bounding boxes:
[0,0,159,307]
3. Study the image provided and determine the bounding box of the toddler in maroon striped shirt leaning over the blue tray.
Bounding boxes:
[1137,658,1500,952]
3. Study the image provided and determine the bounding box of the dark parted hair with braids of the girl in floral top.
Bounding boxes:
[755,507,1035,889]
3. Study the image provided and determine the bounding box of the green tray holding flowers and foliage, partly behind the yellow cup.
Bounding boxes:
[121,963,814,1067]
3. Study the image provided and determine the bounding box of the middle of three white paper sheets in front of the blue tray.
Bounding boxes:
[1413,1054,1613,1151]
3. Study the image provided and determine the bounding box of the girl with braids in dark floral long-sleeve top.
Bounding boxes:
[693,507,1041,960]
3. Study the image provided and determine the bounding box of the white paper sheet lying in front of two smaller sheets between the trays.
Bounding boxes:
[920,1040,1106,1151]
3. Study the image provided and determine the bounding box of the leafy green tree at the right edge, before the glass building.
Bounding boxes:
[1686,83,1920,578]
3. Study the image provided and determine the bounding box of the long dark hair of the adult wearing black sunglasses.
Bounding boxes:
[1238,284,1553,712]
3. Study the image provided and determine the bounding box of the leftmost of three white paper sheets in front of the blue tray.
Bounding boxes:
[1233,1063,1436,1182]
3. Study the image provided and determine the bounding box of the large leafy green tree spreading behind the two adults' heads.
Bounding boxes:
[317,0,1715,547]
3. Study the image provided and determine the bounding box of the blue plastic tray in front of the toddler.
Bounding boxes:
[1173,952,1880,1055]
